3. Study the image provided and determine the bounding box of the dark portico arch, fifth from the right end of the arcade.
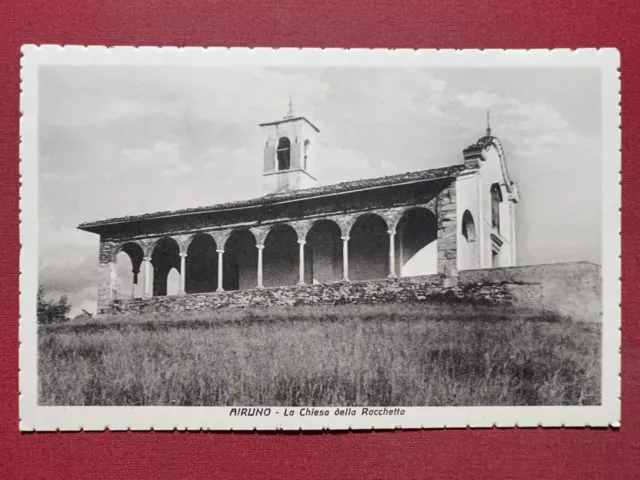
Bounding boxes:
[222,229,258,290]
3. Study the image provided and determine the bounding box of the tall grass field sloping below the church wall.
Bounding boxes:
[38,305,601,406]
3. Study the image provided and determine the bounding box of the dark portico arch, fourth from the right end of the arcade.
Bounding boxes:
[263,223,300,287]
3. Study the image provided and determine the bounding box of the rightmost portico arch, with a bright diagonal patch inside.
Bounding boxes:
[395,207,438,277]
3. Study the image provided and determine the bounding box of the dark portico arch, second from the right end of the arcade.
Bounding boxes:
[349,213,389,280]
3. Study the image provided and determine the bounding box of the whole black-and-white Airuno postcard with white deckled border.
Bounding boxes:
[21,47,620,429]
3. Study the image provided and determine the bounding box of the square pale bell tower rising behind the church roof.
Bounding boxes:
[260,102,320,195]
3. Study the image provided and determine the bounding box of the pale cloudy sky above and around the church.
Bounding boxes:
[39,66,601,315]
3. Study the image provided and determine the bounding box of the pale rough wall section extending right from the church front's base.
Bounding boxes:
[460,262,602,322]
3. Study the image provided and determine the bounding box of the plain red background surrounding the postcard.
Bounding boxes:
[0,0,640,479]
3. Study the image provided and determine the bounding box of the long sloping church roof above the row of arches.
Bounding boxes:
[78,164,466,231]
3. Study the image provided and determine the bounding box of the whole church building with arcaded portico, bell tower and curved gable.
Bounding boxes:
[78,109,519,313]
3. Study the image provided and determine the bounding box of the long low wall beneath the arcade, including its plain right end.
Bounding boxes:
[102,262,602,322]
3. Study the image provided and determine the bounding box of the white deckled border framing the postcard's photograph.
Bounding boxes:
[19,45,621,431]
